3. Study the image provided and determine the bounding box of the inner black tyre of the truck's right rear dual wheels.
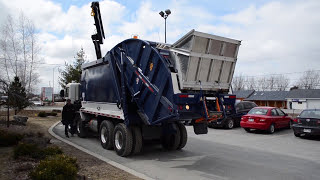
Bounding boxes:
[161,124,181,150]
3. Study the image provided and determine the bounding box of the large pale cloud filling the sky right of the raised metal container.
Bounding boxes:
[199,1,320,82]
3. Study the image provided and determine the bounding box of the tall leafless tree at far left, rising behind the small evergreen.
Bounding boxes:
[0,12,40,93]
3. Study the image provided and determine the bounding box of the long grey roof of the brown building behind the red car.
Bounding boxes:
[245,91,289,101]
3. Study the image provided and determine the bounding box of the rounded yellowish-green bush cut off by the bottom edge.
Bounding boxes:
[29,155,78,180]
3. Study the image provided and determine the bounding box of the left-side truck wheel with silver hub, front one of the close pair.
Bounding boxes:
[99,120,114,150]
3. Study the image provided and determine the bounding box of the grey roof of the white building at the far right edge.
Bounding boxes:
[287,89,320,99]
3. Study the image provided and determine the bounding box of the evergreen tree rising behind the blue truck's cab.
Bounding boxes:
[59,48,85,88]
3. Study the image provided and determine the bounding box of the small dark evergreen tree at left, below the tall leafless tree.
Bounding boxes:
[8,76,30,114]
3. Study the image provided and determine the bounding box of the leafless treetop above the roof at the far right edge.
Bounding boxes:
[297,70,320,89]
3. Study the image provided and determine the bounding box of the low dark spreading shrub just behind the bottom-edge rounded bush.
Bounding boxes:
[13,143,62,159]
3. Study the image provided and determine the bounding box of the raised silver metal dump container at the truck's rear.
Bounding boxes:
[169,30,241,91]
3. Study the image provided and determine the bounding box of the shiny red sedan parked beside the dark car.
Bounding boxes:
[240,107,292,134]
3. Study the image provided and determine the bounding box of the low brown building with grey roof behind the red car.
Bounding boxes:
[244,91,289,109]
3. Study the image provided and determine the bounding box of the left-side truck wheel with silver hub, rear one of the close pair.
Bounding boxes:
[113,123,133,157]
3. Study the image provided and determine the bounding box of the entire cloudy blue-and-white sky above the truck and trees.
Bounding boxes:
[0,0,320,91]
